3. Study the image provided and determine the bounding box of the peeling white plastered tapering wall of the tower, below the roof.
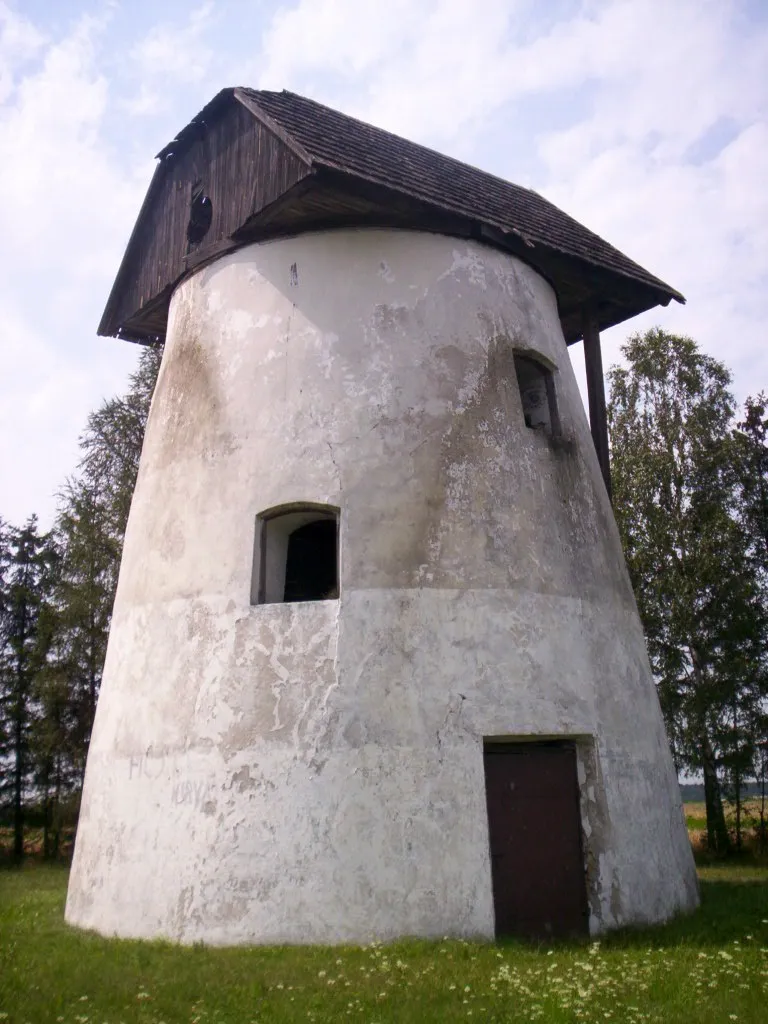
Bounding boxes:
[67,230,697,944]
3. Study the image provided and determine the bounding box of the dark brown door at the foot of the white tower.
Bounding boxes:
[484,743,588,938]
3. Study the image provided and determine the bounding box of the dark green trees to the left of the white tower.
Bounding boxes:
[0,348,162,859]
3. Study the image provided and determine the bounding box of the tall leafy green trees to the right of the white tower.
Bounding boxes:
[608,329,768,851]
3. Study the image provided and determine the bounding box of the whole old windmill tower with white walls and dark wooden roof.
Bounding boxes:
[67,89,697,944]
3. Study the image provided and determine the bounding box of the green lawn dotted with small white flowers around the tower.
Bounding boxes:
[0,866,768,1024]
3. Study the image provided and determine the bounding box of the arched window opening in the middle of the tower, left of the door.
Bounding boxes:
[251,503,339,604]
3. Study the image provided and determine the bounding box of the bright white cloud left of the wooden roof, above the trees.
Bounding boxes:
[0,9,144,521]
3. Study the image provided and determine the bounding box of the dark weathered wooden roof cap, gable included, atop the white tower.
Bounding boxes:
[98,89,685,343]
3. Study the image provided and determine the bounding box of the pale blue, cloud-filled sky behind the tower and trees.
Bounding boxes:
[0,0,768,526]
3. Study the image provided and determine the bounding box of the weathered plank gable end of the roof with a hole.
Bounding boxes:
[98,102,310,340]
